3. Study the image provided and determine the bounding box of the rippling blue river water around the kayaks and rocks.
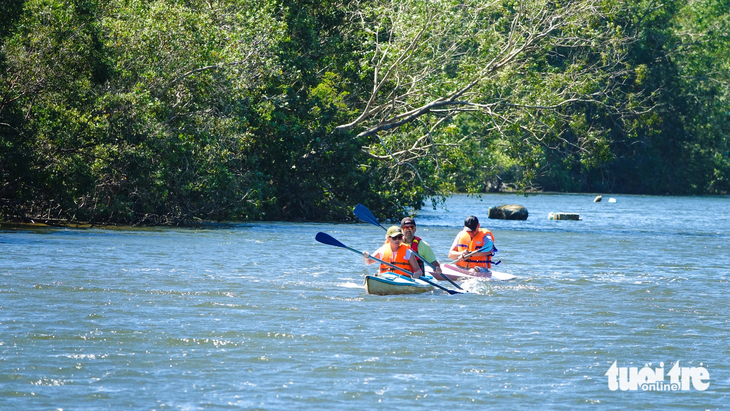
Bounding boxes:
[0,194,730,410]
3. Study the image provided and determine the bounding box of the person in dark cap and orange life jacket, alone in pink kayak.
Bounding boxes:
[449,215,494,273]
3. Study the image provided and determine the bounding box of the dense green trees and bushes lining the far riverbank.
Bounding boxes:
[0,0,730,224]
